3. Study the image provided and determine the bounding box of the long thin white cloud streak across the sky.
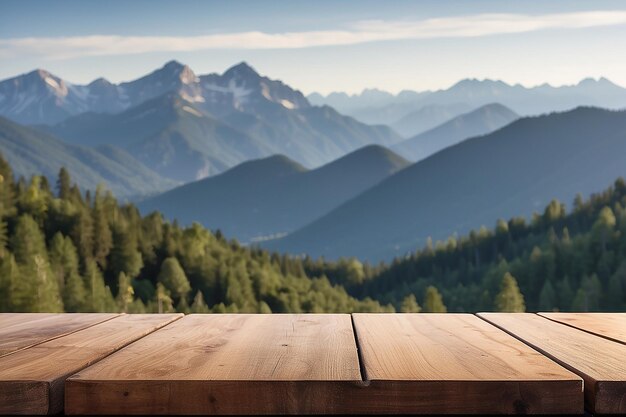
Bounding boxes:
[0,11,626,59]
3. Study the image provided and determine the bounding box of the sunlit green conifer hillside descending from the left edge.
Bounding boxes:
[0,154,393,313]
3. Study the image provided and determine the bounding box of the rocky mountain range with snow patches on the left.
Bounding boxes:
[0,61,401,182]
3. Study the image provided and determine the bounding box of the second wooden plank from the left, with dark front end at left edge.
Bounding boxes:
[0,314,182,414]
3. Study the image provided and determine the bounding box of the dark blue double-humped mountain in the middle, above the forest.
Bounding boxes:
[138,146,408,242]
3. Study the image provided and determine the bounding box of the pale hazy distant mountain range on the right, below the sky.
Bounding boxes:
[308,78,626,138]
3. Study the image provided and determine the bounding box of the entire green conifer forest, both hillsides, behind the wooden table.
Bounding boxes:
[0,154,626,313]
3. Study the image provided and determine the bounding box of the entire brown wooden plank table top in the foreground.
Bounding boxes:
[0,313,626,415]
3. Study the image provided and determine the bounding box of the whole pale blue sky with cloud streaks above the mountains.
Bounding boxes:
[0,0,626,93]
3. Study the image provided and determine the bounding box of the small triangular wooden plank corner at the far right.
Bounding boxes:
[538,313,626,343]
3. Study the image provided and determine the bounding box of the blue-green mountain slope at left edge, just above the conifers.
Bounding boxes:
[0,117,176,198]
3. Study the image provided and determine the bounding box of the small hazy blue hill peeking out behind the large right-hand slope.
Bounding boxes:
[392,103,519,161]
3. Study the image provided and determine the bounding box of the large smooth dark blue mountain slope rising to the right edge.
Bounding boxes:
[265,108,626,260]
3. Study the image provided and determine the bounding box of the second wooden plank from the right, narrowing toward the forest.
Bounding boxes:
[480,313,626,414]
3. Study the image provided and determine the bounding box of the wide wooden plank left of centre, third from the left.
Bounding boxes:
[65,314,362,414]
